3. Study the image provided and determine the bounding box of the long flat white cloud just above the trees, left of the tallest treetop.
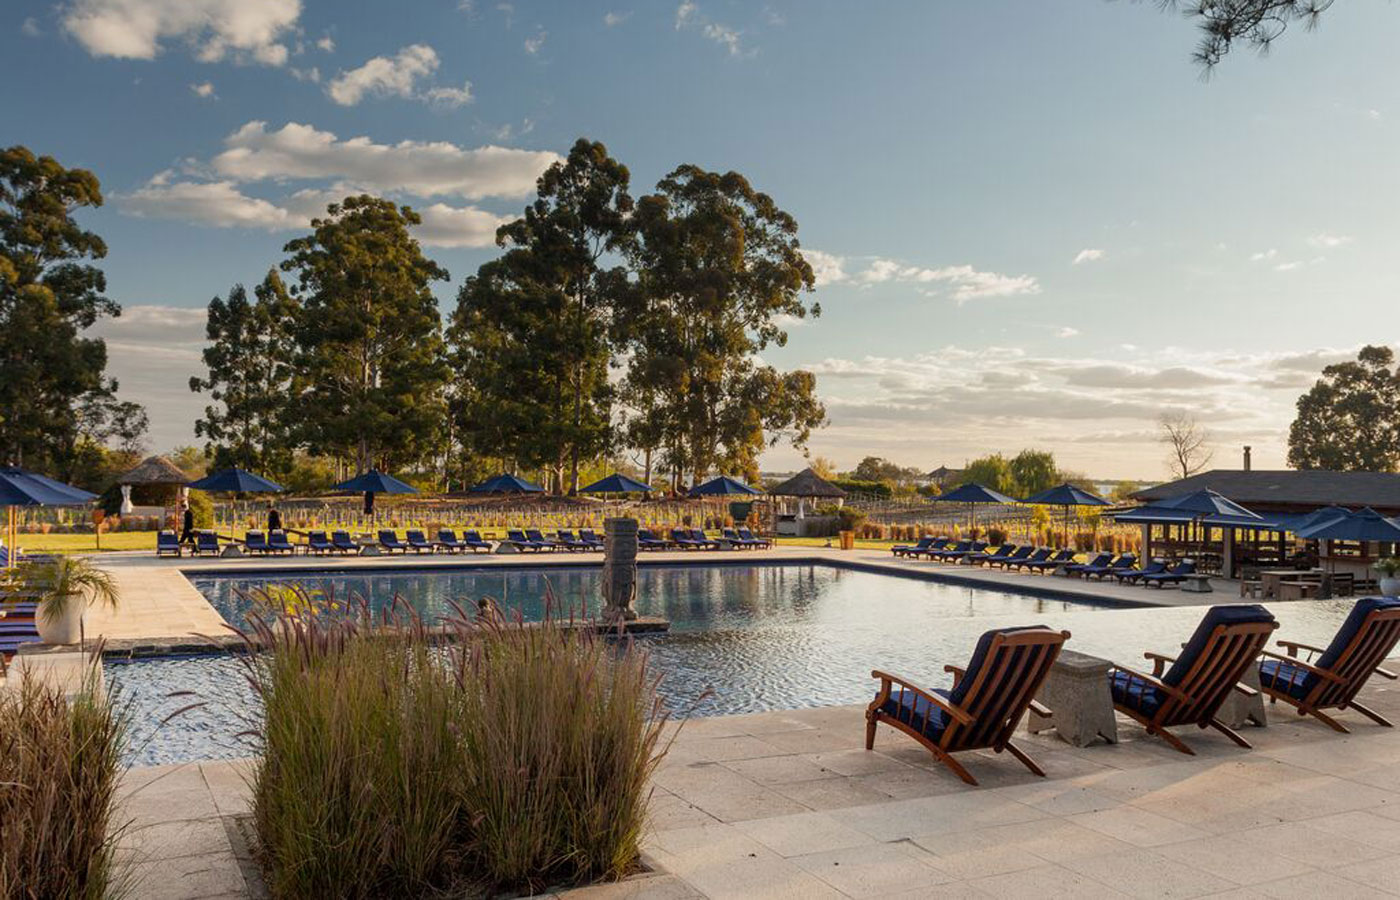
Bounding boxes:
[210,122,561,200]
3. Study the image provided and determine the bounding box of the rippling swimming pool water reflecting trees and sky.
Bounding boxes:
[106,564,1351,764]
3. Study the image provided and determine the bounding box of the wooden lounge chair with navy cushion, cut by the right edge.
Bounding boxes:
[1259,596,1400,733]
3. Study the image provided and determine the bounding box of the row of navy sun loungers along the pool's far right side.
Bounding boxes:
[892,537,1197,588]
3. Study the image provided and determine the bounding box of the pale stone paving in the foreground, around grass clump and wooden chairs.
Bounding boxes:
[114,661,1400,900]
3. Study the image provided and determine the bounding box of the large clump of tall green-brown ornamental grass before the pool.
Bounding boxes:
[244,591,666,897]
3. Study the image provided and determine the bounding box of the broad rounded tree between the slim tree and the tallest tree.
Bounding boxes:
[281,196,449,470]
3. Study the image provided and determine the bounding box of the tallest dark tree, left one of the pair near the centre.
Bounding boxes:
[449,139,633,493]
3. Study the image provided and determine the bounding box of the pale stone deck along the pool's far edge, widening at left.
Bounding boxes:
[76,547,1239,647]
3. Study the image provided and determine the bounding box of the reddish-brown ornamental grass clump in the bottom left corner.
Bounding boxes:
[0,655,132,900]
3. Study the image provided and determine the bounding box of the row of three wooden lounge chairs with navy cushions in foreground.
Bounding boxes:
[865,598,1400,785]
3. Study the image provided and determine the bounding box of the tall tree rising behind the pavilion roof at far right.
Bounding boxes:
[1288,346,1400,472]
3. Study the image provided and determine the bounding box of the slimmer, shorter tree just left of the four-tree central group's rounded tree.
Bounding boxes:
[189,269,302,474]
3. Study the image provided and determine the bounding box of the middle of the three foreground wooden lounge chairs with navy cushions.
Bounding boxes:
[1109,603,1278,756]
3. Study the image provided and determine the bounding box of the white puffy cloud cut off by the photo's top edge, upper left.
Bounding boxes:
[63,0,301,66]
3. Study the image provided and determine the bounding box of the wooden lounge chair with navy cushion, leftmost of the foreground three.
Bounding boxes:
[865,626,1070,784]
